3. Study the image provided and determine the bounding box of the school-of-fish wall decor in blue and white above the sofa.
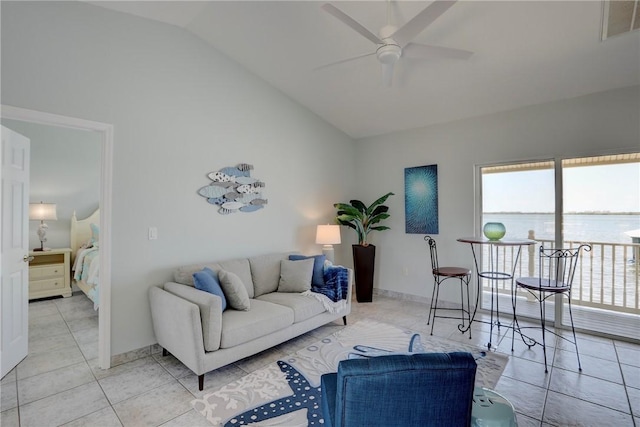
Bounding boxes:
[197,163,267,215]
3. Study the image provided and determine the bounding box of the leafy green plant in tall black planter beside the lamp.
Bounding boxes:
[333,193,394,302]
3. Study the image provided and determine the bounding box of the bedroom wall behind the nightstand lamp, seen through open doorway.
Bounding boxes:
[1,119,100,248]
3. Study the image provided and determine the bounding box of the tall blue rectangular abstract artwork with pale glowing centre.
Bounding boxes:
[404,165,438,234]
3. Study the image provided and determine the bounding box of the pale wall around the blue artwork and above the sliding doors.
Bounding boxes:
[351,86,640,301]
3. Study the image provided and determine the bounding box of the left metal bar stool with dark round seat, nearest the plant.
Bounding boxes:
[424,236,471,339]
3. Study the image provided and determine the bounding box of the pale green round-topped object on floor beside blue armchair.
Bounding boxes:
[471,387,518,427]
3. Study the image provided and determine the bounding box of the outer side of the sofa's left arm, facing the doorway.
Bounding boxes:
[149,286,204,375]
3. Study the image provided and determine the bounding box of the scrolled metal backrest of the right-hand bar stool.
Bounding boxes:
[538,244,591,288]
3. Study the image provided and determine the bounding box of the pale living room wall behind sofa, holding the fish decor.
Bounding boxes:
[1,2,355,354]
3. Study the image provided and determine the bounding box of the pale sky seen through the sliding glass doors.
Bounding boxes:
[482,163,640,212]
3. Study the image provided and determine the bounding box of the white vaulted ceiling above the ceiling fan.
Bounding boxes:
[91,0,640,138]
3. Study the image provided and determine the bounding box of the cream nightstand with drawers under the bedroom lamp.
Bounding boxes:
[29,248,71,300]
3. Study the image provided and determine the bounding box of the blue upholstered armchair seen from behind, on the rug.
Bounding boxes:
[321,352,477,427]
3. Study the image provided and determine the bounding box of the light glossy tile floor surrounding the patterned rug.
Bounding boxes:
[0,294,640,427]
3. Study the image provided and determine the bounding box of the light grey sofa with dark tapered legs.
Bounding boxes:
[149,253,353,390]
